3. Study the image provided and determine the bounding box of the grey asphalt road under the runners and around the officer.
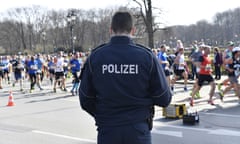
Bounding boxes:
[0,76,240,144]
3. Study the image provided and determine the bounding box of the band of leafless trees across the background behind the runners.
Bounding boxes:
[0,4,240,53]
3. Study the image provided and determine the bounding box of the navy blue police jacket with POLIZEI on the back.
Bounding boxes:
[79,36,172,126]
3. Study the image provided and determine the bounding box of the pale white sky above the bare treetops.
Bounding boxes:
[0,0,240,26]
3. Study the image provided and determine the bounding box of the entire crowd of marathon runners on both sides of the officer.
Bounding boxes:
[0,40,240,106]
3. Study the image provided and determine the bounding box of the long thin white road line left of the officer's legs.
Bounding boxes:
[32,130,96,143]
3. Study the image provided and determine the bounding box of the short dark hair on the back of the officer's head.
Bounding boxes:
[111,11,133,33]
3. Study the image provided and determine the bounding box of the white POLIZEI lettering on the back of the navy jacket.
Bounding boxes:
[102,64,138,74]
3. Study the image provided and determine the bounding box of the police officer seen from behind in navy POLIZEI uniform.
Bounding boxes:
[79,12,172,144]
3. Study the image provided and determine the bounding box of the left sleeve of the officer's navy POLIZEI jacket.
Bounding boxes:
[79,59,96,117]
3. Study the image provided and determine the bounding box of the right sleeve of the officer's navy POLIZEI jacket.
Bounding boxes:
[150,57,172,107]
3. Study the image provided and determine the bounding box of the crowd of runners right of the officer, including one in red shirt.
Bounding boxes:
[153,40,240,106]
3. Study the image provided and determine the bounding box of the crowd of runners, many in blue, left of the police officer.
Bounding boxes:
[0,51,84,95]
